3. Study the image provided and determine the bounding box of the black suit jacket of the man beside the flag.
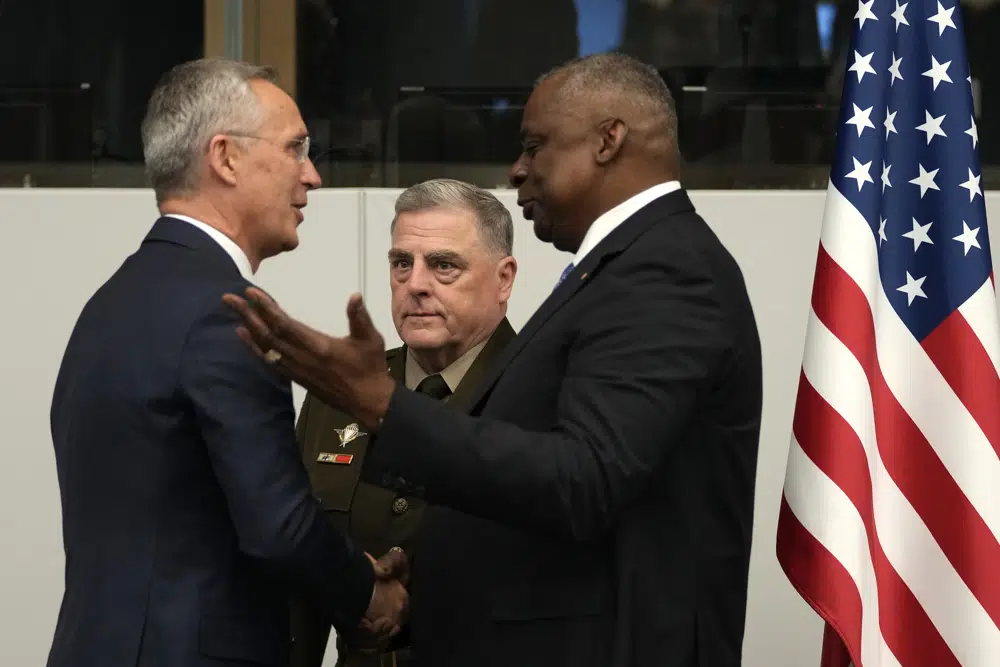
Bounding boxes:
[369,191,762,667]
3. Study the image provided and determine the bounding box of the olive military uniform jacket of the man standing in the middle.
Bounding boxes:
[291,318,515,667]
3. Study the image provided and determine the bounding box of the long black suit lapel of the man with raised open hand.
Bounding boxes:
[470,185,694,411]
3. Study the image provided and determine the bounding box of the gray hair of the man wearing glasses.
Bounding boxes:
[142,58,277,203]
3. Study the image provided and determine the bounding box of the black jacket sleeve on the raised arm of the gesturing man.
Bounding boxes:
[369,252,731,541]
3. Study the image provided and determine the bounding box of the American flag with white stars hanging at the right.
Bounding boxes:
[777,0,1000,667]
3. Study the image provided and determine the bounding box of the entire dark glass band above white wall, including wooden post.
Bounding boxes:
[0,0,1000,189]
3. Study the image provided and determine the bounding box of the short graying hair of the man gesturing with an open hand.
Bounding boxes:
[536,53,677,142]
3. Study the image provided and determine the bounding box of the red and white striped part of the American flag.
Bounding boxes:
[777,185,1000,667]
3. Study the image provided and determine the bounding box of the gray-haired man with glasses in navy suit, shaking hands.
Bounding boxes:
[48,60,406,667]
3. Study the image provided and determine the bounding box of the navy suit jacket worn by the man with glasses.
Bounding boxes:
[48,219,373,667]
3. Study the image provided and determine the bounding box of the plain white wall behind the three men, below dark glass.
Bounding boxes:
[0,189,1000,667]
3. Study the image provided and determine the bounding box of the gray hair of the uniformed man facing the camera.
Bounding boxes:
[389,178,514,257]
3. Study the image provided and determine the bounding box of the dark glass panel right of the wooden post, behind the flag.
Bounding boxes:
[296,0,1000,189]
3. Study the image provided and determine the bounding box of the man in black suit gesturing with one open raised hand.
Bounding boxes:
[226,54,762,667]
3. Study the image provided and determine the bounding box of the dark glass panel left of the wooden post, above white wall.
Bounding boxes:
[0,0,205,187]
